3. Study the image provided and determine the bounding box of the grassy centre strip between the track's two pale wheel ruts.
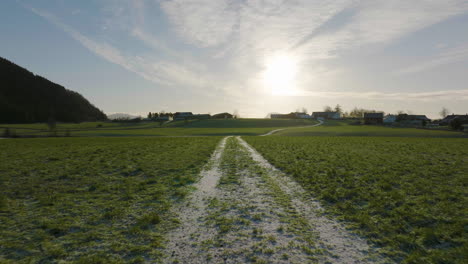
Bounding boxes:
[202,138,322,263]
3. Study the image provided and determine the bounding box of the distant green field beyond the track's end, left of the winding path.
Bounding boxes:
[0,118,317,137]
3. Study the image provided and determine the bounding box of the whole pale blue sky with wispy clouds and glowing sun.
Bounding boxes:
[0,0,468,118]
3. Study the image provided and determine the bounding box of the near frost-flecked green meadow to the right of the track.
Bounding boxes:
[245,135,468,263]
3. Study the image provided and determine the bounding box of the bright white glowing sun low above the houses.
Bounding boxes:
[263,54,297,95]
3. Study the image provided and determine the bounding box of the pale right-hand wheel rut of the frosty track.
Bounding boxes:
[237,137,391,263]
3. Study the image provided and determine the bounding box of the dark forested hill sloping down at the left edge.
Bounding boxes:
[0,57,107,123]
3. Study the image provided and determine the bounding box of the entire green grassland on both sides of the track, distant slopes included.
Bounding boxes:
[0,119,468,263]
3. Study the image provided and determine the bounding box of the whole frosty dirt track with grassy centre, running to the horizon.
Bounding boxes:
[164,137,387,263]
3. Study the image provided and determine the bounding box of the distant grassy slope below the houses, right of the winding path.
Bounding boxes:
[275,121,468,138]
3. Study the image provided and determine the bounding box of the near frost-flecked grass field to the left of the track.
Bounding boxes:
[0,137,219,263]
